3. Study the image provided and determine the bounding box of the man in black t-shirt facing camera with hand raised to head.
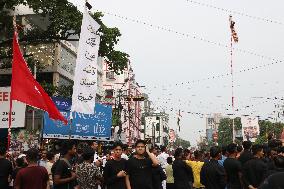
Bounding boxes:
[126,140,159,189]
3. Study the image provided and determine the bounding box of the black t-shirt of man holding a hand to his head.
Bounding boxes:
[126,157,152,189]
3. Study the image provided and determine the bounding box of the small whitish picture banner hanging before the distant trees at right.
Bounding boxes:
[241,117,259,142]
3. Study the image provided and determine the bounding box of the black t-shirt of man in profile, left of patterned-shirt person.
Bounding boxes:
[51,160,75,189]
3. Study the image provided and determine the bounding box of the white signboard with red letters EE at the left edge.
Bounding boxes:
[0,87,26,128]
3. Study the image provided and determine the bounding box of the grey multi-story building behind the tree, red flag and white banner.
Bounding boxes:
[0,5,104,130]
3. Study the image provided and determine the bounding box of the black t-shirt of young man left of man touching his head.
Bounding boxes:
[104,159,127,189]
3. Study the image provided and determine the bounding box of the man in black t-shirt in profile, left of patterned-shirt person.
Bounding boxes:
[51,140,77,189]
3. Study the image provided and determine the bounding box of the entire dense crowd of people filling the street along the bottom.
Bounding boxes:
[0,137,284,189]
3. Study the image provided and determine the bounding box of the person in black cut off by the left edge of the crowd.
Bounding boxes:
[0,145,13,189]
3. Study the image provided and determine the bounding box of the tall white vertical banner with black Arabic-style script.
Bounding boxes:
[71,10,100,114]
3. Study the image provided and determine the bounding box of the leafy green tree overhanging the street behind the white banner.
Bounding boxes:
[0,0,129,74]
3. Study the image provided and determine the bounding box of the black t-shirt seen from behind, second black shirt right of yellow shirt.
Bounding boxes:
[223,158,242,189]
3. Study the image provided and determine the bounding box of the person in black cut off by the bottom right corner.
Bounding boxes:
[259,156,284,189]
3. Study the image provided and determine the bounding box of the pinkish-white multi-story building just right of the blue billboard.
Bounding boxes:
[102,61,142,144]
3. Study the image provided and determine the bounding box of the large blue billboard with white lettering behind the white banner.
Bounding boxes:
[43,98,112,140]
